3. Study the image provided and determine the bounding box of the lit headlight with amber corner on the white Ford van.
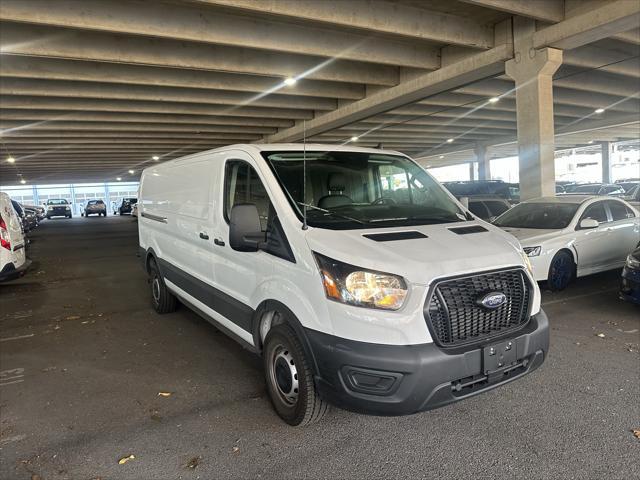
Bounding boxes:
[314,253,407,310]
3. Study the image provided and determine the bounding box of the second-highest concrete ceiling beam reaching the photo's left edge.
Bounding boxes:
[0,22,399,87]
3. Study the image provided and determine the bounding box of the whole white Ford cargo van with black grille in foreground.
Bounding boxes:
[138,144,549,425]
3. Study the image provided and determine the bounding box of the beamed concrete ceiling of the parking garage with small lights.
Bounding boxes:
[0,0,640,184]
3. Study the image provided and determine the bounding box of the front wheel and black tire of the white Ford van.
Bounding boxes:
[262,324,329,426]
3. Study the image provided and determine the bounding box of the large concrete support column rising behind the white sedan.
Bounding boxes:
[505,17,562,200]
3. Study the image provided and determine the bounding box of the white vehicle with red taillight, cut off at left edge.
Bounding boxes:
[0,192,31,282]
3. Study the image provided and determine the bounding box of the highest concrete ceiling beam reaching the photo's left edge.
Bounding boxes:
[0,0,440,69]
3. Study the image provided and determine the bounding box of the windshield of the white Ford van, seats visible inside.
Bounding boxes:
[262,151,468,230]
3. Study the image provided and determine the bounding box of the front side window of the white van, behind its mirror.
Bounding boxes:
[224,160,271,232]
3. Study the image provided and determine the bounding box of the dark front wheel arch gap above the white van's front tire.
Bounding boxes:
[251,300,318,375]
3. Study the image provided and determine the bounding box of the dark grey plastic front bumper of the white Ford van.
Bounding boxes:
[306,310,549,415]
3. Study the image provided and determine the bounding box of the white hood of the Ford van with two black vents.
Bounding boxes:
[306,222,524,285]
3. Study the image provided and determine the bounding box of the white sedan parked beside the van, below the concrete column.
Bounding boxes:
[493,195,640,290]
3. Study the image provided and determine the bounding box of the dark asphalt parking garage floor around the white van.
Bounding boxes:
[0,217,640,479]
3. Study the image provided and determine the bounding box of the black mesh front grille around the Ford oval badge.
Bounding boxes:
[424,269,532,347]
